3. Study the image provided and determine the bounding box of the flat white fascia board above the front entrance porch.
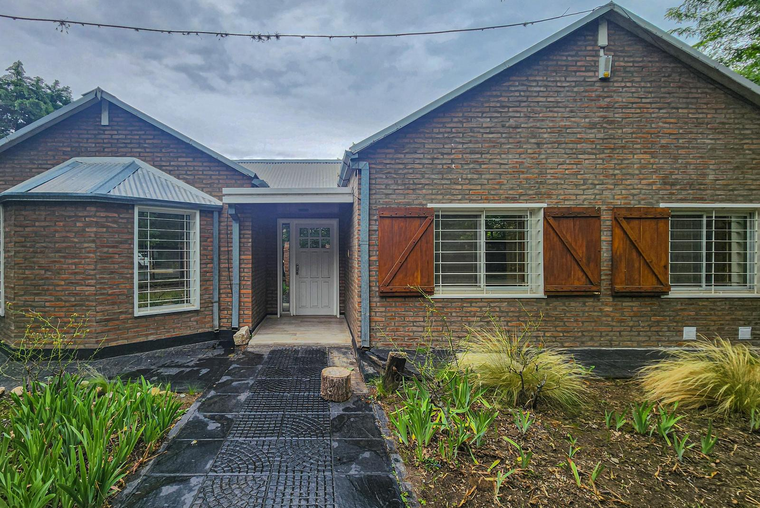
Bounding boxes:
[222,187,354,205]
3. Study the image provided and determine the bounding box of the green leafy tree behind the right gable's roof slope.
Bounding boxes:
[666,0,760,84]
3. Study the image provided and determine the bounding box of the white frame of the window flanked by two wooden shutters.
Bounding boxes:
[428,203,546,299]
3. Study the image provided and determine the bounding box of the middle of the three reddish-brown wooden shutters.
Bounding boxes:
[544,207,602,295]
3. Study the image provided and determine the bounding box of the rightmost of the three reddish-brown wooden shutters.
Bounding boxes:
[612,208,670,295]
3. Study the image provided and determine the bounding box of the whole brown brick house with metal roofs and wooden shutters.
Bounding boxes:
[0,4,760,354]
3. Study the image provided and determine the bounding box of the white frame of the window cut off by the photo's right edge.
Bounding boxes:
[660,203,760,298]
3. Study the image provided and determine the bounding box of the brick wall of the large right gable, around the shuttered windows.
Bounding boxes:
[349,19,760,346]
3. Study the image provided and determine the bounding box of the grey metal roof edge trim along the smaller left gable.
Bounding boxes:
[0,88,256,183]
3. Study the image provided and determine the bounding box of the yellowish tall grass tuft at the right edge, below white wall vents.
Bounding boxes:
[641,338,760,415]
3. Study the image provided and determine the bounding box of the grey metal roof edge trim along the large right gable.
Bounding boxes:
[349,2,760,154]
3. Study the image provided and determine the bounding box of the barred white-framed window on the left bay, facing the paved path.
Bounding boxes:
[135,207,200,315]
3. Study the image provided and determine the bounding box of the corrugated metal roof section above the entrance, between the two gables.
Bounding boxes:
[236,159,342,189]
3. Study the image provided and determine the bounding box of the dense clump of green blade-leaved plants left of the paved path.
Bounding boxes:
[0,374,181,508]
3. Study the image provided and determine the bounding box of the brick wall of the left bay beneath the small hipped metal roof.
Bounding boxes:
[0,202,213,348]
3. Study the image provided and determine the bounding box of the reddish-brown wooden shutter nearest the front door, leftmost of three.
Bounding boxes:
[377,207,435,296]
